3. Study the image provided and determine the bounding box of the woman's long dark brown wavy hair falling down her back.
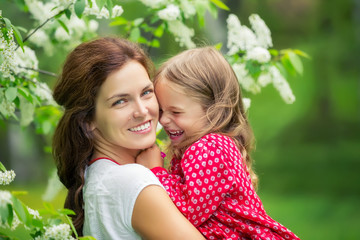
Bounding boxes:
[53,37,153,236]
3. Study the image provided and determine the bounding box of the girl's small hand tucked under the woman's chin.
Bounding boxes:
[135,144,164,169]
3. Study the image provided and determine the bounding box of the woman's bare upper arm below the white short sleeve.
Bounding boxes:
[131,185,205,240]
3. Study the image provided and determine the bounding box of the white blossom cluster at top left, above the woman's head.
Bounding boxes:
[25,0,124,56]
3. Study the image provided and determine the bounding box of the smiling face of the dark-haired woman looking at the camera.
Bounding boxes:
[90,61,159,153]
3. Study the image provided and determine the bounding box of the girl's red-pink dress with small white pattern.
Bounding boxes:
[152,133,299,240]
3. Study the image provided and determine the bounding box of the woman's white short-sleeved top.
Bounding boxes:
[83,159,162,240]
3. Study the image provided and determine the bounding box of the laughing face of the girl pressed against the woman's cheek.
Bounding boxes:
[155,79,206,146]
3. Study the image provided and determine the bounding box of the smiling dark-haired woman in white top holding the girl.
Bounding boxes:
[53,38,203,239]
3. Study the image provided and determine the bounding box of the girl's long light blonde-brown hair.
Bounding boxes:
[154,47,258,187]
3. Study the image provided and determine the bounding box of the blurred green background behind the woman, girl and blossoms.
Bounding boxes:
[0,0,360,240]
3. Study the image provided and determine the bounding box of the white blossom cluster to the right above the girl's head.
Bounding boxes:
[227,14,295,103]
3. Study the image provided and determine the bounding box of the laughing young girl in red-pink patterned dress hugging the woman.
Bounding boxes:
[137,47,299,240]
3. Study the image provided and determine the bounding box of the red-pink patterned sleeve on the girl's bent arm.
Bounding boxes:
[152,141,236,226]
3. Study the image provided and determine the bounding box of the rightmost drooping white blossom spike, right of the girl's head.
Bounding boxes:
[269,66,295,104]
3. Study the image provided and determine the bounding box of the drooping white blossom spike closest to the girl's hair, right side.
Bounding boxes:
[232,63,260,94]
